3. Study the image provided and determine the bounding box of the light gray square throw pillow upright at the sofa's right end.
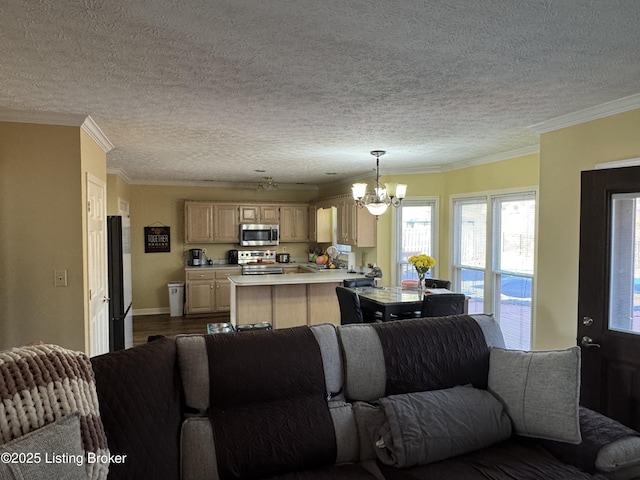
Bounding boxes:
[488,347,582,444]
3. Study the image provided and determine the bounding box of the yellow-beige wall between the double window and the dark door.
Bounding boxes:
[534,110,640,349]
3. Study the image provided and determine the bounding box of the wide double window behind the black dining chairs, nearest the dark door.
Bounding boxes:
[453,192,536,350]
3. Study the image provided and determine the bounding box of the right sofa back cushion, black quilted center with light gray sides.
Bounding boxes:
[338,315,503,401]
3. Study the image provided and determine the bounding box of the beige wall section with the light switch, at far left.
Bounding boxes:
[0,122,85,350]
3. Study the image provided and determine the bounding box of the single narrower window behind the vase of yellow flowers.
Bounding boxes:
[395,198,438,285]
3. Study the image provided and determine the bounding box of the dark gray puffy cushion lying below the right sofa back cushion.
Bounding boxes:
[360,386,511,468]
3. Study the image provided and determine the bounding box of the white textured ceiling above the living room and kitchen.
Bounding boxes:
[0,0,640,184]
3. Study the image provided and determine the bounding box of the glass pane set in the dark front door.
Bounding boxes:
[609,193,640,335]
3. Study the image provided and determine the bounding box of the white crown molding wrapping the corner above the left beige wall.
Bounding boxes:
[0,108,114,153]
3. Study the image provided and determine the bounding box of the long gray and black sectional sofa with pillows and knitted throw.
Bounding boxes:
[0,315,640,480]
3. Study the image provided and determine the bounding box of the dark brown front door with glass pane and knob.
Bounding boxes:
[577,167,640,429]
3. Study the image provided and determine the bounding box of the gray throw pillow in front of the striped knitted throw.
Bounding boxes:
[0,413,87,480]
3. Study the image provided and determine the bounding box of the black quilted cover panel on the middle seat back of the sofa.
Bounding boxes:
[205,327,338,479]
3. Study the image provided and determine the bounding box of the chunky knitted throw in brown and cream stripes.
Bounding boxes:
[0,345,109,479]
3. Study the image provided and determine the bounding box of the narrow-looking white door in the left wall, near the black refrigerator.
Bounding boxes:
[87,174,109,357]
